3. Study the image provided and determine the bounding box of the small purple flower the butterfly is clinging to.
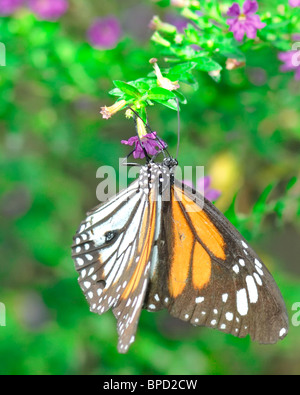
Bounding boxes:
[121,132,167,159]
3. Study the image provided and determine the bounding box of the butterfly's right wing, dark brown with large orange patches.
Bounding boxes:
[145,182,288,343]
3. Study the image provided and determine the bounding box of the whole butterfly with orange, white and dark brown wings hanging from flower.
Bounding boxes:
[72,157,288,353]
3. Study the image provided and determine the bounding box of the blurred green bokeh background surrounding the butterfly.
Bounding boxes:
[0,0,300,375]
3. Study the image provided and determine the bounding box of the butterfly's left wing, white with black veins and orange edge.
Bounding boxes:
[72,180,157,353]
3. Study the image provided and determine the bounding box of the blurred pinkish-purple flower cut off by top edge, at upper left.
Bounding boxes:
[28,0,69,21]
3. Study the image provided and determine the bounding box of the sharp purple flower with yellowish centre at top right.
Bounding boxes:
[227,0,266,41]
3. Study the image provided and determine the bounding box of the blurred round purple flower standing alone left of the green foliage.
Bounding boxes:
[87,16,122,49]
